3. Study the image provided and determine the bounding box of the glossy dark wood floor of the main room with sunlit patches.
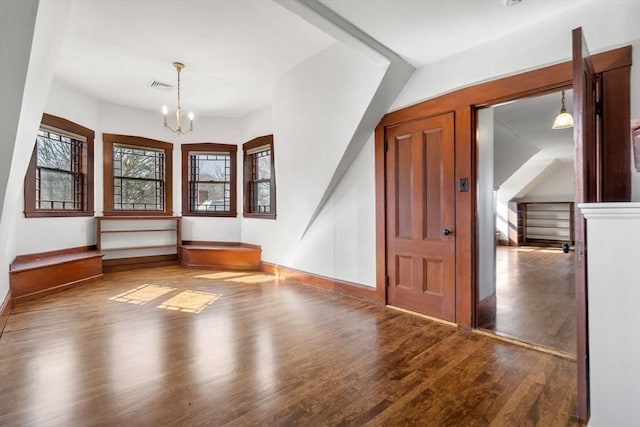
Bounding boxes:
[0,266,579,426]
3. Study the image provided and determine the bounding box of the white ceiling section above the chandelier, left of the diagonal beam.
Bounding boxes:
[55,0,335,117]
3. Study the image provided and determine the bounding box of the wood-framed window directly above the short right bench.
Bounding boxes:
[181,143,238,216]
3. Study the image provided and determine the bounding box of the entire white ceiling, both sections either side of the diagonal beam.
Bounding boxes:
[55,0,591,117]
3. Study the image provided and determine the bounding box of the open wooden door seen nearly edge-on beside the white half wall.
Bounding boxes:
[573,28,600,420]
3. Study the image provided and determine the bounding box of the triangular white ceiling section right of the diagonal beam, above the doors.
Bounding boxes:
[321,0,592,67]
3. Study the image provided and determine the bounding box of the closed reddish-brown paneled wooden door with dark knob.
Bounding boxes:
[385,113,455,322]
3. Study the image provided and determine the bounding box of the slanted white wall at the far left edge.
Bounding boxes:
[0,1,69,301]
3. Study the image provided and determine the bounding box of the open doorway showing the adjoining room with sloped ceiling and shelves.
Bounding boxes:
[477,88,576,357]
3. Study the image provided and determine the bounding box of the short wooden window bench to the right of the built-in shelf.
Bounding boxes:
[180,241,262,271]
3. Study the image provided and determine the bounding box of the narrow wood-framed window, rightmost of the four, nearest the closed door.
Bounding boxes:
[243,135,276,219]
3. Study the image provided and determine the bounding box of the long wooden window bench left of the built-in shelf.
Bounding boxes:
[9,246,102,303]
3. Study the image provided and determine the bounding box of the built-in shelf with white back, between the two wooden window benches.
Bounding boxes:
[96,216,181,271]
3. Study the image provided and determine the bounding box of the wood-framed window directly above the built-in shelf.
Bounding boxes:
[102,133,173,215]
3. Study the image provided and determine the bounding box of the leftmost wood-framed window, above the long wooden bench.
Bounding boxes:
[24,114,94,218]
